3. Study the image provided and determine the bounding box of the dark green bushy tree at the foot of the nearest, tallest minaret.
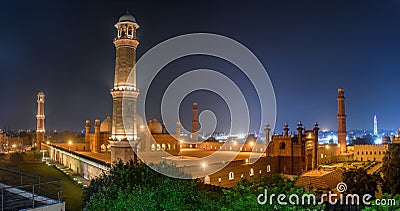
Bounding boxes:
[83,161,217,210]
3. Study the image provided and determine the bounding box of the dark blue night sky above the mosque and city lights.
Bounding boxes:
[0,0,400,131]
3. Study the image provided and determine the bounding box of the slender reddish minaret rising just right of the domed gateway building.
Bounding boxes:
[337,88,347,154]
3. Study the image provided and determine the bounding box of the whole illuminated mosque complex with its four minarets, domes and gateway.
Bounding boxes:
[36,13,388,190]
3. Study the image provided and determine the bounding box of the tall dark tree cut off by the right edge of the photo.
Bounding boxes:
[381,144,400,194]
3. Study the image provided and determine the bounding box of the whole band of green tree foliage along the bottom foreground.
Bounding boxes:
[83,161,323,210]
